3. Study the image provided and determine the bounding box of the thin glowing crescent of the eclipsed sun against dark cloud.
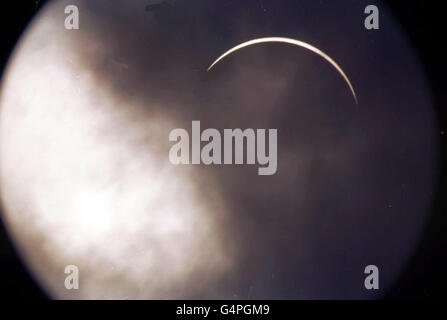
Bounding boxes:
[207,37,358,104]
